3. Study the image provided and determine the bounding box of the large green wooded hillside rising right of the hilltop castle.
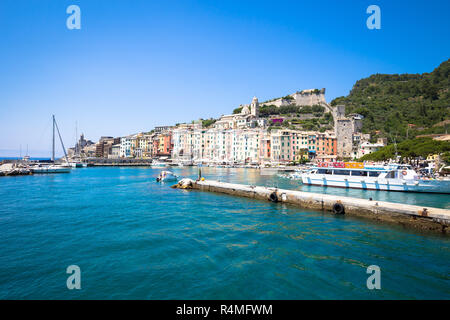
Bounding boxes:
[331,60,450,142]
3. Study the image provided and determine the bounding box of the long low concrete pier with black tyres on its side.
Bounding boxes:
[173,179,450,235]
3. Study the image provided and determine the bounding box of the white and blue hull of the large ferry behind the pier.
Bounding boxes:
[301,174,450,194]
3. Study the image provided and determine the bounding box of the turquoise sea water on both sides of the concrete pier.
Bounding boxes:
[0,167,450,299]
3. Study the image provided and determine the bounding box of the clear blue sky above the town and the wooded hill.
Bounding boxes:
[0,0,450,156]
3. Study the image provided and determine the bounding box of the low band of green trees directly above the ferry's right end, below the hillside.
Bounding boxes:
[360,138,450,163]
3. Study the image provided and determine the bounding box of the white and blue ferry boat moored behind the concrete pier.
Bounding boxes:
[300,162,450,193]
